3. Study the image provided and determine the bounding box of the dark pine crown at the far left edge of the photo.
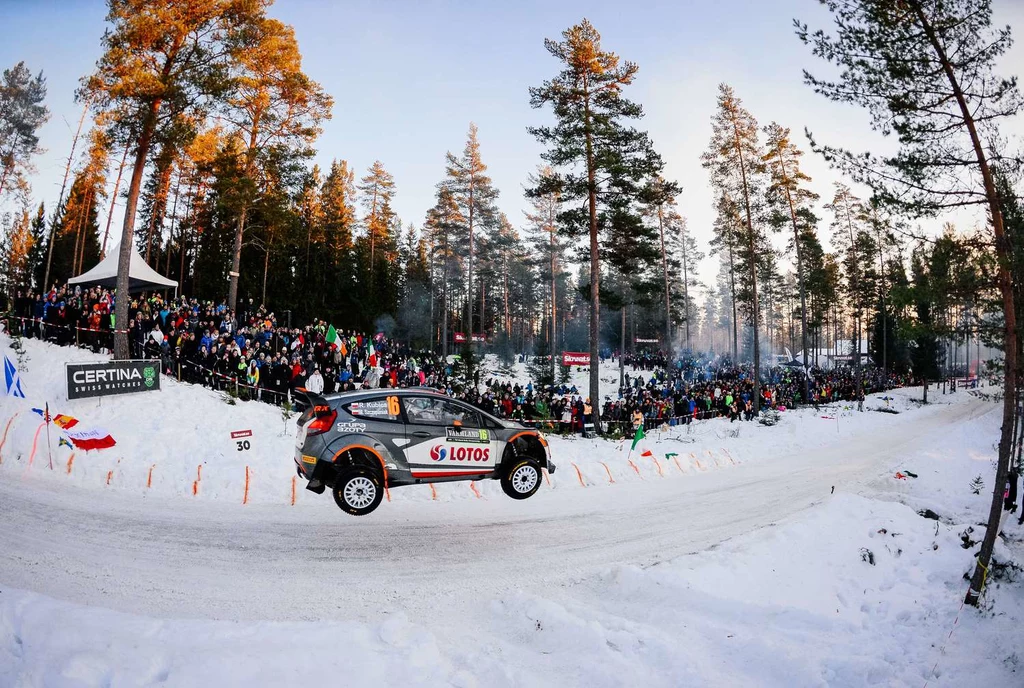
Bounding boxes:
[0,61,50,200]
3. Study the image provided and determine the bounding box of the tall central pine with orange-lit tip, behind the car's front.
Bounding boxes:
[527,19,663,431]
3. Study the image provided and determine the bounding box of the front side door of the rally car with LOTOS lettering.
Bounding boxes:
[404,395,496,478]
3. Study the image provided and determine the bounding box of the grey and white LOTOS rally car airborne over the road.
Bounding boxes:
[295,388,555,516]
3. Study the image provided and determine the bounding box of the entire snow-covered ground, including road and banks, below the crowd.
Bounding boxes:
[0,335,1024,686]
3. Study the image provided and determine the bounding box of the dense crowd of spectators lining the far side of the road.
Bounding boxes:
[6,287,909,433]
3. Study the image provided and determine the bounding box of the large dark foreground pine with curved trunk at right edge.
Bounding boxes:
[797,0,1024,605]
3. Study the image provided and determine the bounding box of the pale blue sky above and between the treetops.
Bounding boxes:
[0,0,1024,283]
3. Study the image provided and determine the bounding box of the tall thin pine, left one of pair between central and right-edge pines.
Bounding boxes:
[701,84,765,413]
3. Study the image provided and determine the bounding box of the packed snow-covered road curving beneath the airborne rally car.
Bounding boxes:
[0,398,992,621]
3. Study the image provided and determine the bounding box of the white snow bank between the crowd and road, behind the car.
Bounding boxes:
[0,338,941,506]
